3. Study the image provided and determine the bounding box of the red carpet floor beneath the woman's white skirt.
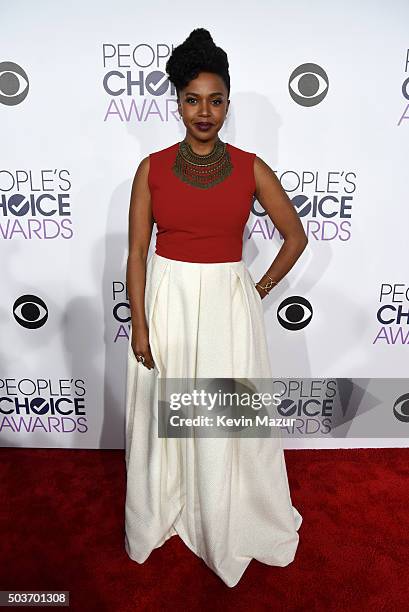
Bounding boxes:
[0,448,409,612]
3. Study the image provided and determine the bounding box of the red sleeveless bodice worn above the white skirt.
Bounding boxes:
[148,142,256,263]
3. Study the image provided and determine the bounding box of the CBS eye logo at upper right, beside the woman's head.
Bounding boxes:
[288,64,329,106]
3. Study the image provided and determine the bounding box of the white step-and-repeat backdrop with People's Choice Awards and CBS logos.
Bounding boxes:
[0,0,409,448]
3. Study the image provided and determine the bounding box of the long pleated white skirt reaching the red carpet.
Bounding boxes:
[125,253,302,587]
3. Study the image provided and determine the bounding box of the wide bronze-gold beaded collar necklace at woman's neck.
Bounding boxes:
[172,138,233,189]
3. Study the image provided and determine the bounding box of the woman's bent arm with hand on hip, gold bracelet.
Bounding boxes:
[254,156,308,299]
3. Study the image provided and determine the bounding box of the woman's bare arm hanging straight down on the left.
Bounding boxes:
[126,156,154,370]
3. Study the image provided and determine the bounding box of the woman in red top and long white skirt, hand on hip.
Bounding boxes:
[125,28,307,587]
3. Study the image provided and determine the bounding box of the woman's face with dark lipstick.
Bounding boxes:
[178,72,230,142]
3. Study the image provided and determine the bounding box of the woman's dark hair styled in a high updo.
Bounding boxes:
[166,28,230,99]
